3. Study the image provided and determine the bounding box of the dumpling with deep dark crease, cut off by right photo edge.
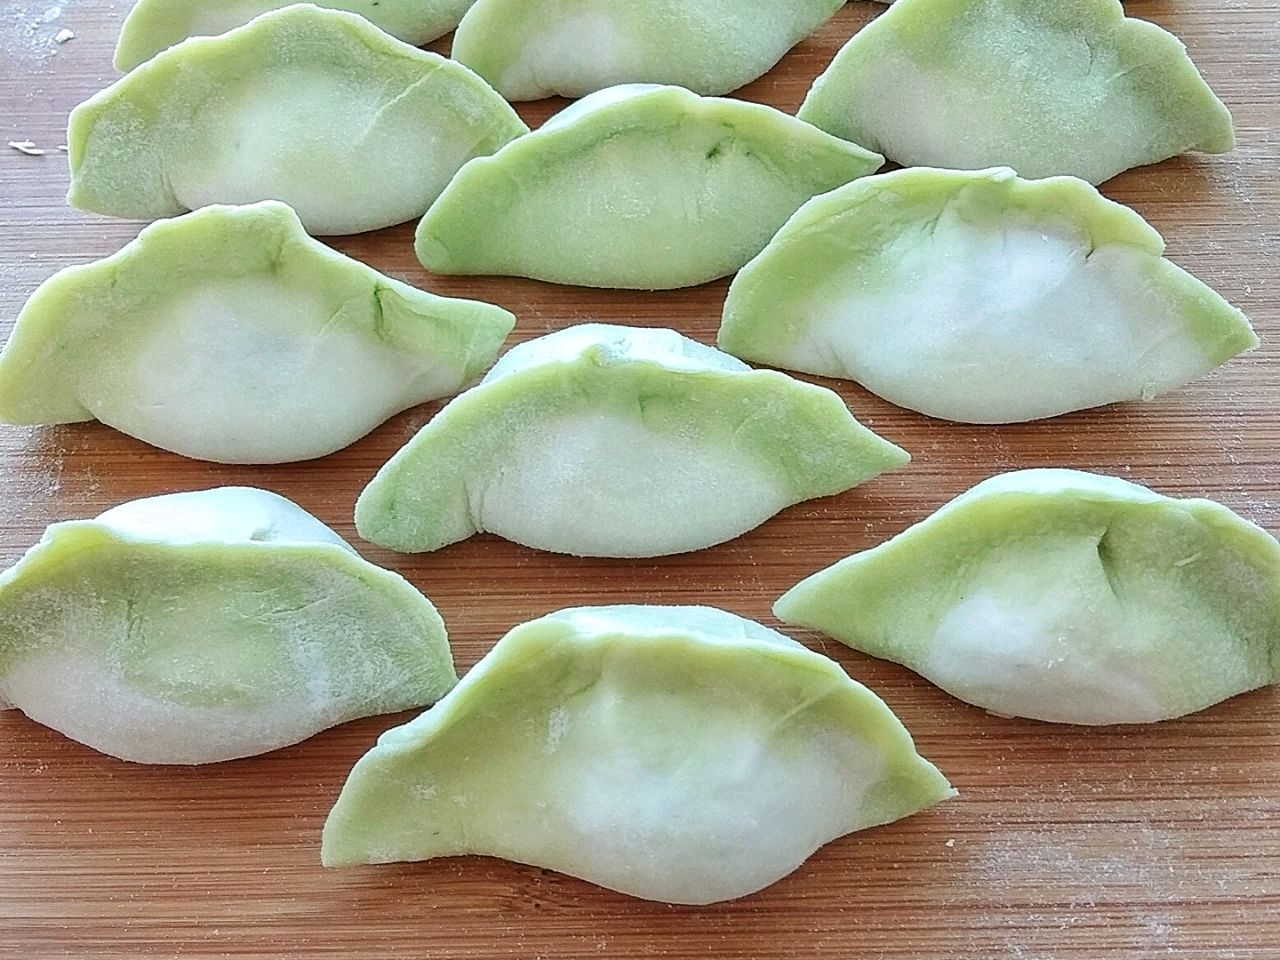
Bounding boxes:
[773,471,1280,724]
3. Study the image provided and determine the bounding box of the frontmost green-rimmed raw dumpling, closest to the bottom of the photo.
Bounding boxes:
[323,607,955,904]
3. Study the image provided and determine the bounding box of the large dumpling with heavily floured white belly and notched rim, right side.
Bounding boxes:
[719,168,1258,424]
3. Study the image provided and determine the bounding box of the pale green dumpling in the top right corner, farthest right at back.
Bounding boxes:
[799,0,1234,183]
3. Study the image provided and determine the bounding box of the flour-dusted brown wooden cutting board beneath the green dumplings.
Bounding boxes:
[0,0,1280,960]
